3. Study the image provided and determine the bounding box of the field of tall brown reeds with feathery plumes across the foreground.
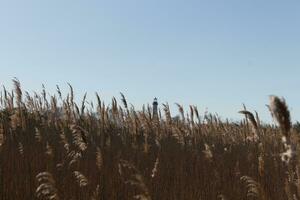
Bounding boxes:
[0,80,300,200]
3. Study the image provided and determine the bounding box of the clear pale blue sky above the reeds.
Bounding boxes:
[0,0,300,122]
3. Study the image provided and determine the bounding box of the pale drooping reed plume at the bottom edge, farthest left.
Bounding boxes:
[35,172,59,200]
